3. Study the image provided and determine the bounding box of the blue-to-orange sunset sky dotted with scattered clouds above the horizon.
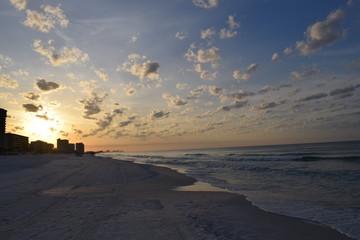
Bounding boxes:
[0,0,360,151]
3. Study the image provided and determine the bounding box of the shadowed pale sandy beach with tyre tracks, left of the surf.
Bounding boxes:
[0,155,350,240]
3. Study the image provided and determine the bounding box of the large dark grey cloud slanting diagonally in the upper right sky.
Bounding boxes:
[295,9,346,56]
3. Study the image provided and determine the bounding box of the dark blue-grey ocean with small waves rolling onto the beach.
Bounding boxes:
[98,141,360,239]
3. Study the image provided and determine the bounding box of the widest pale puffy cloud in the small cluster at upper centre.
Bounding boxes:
[184,44,220,66]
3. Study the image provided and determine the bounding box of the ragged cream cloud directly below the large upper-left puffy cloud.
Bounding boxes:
[33,40,89,66]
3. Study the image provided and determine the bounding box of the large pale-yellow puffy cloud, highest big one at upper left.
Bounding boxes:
[24,5,69,33]
